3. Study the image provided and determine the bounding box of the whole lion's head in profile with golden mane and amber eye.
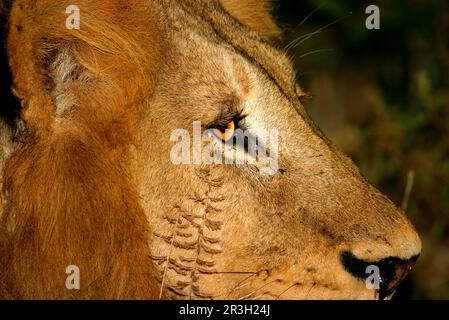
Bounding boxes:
[0,0,421,299]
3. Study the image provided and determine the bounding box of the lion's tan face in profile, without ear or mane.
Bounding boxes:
[133,0,421,299]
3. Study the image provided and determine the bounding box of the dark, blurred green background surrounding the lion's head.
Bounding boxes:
[0,0,449,299]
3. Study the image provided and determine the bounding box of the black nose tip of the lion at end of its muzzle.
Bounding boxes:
[340,251,419,300]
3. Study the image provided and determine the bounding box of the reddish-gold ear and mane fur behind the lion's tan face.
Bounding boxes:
[3,1,164,298]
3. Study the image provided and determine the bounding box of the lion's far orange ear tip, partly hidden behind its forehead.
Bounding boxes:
[220,0,280,40]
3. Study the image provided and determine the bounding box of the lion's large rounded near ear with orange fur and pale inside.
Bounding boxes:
[7,0,162,138]
